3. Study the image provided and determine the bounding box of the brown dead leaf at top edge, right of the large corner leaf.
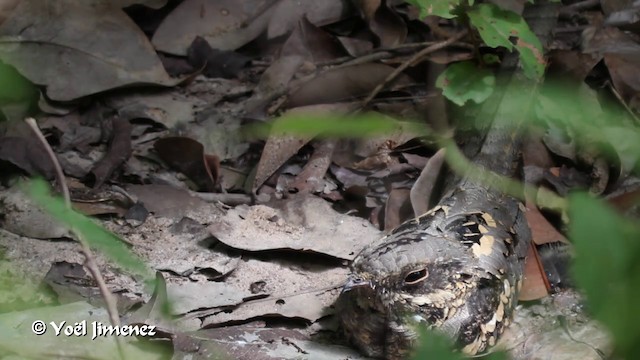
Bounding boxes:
[151,0,276,55]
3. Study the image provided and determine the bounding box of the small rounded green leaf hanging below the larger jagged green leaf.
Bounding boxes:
[436,61,496,106]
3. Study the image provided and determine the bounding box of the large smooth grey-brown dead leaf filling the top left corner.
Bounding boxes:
[0,0,178,101]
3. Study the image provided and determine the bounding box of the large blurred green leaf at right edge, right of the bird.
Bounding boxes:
[569,193,640,359]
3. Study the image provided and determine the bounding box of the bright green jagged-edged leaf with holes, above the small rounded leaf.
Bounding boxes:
[467,4,546,79]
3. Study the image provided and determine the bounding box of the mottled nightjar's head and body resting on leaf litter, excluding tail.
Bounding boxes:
[337,181,530,360]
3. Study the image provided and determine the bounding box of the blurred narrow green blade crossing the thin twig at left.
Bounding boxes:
[26,180,152,279]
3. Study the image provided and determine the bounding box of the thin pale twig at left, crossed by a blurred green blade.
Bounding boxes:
[25,118,125,359]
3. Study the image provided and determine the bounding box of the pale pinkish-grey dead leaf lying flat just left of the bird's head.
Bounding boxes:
[209,195,380,260]
